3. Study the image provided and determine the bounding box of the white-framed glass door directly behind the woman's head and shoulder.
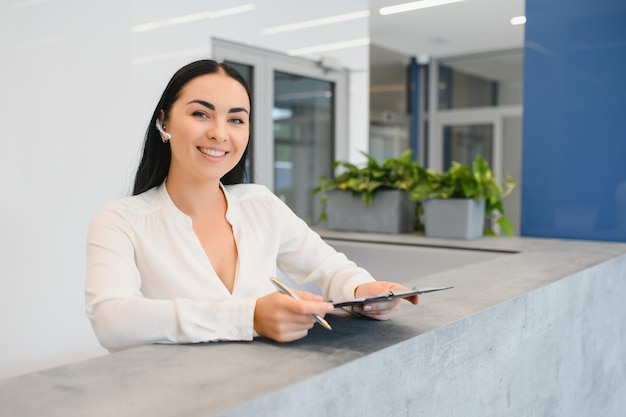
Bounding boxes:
[212,40,348,223]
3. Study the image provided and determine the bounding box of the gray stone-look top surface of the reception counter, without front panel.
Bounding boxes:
[0,230,626,417]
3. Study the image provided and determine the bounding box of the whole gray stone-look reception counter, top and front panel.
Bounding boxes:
[0,230,626,417]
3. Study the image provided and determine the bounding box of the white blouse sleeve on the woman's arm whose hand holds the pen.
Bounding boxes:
[85,208,256,350]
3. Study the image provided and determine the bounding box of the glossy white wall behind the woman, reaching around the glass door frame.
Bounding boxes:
[0,0,368,378]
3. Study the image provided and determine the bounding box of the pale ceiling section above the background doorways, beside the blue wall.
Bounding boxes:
[369,0,525,80]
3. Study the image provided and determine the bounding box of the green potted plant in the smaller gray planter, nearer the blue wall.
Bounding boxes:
[411,155,515,239]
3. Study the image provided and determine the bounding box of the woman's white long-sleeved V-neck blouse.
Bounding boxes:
[85,184,374,350]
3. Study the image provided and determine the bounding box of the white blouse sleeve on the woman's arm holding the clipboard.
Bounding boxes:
[275,192,375,300]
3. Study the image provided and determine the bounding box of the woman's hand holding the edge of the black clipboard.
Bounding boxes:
[352,281,418,320]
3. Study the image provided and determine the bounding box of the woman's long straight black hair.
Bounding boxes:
[133,59,252,195]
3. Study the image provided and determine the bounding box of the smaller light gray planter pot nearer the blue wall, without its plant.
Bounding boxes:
[422,198,485,239]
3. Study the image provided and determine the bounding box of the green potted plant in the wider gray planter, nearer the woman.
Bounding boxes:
[313,150,425,233]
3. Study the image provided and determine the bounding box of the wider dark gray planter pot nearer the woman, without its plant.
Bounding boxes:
[326,190,416,233]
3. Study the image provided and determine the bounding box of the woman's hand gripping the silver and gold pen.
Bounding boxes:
[254,290,334,342]
